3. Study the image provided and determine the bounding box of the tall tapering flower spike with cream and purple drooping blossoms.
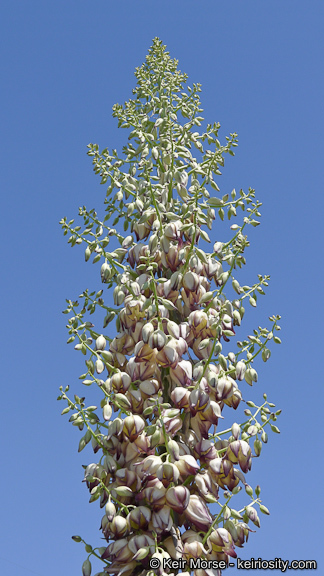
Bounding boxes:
[59,38,280,576]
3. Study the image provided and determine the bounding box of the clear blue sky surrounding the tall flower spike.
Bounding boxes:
[0,0,324,576]
